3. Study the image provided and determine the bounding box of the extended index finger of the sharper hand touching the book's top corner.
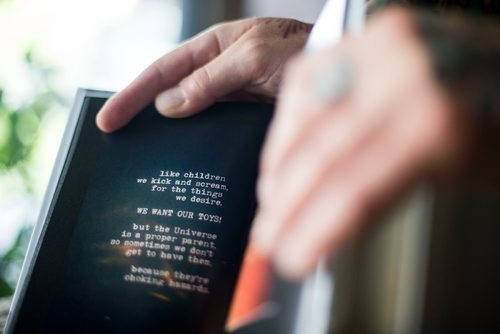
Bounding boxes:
[96,21,249,132]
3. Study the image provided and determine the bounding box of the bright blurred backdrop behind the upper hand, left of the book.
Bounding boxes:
[0,0,323,297]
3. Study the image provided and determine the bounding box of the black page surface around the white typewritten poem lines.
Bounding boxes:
[6,94,272,333]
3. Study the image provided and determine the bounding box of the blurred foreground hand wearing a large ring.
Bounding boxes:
[252,9,465,279]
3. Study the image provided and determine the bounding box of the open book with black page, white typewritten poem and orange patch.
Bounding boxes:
[6,90,296,333]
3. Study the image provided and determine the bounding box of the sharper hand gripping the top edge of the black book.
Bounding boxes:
[97,18,312,132]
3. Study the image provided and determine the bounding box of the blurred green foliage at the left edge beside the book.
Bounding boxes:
[0,47,66,297]
